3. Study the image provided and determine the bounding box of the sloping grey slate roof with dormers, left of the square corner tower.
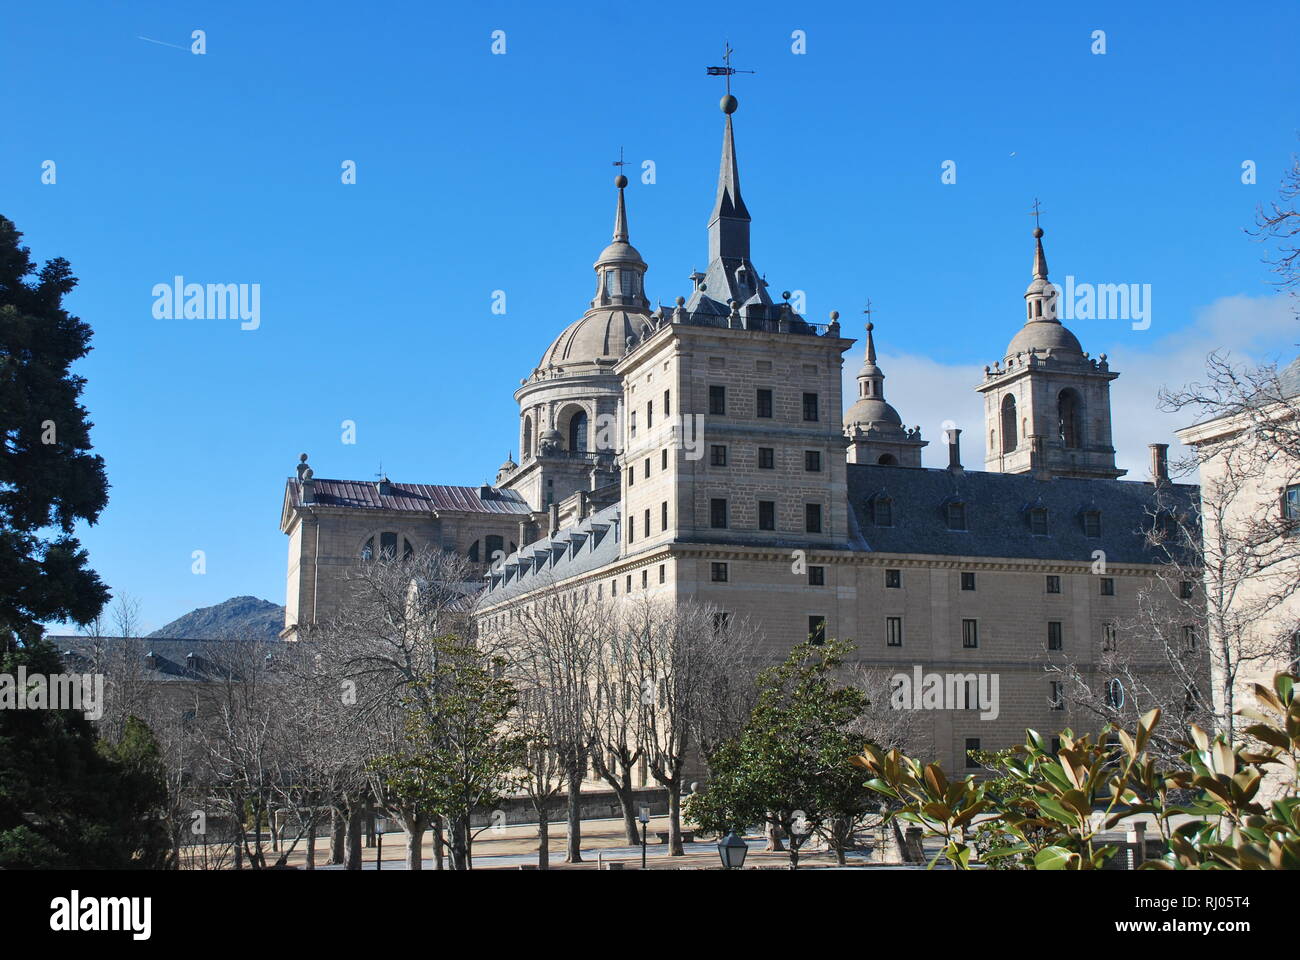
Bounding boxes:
[484,503,620,604]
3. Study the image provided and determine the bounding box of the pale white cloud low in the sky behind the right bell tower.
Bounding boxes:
[844,295,1300,480]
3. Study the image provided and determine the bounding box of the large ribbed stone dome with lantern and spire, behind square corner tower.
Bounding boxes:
[502,174,651,510]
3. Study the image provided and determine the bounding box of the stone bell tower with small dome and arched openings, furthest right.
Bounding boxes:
[975,228,1127,480]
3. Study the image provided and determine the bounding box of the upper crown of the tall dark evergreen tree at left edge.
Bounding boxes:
[0,216,108,649]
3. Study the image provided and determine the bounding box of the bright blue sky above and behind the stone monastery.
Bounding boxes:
[0,0,1300,628]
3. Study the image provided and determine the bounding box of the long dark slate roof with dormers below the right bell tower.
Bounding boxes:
[848,463,1199,563]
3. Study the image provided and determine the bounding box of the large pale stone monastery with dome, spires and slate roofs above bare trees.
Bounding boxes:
[282,96,1199,770]
